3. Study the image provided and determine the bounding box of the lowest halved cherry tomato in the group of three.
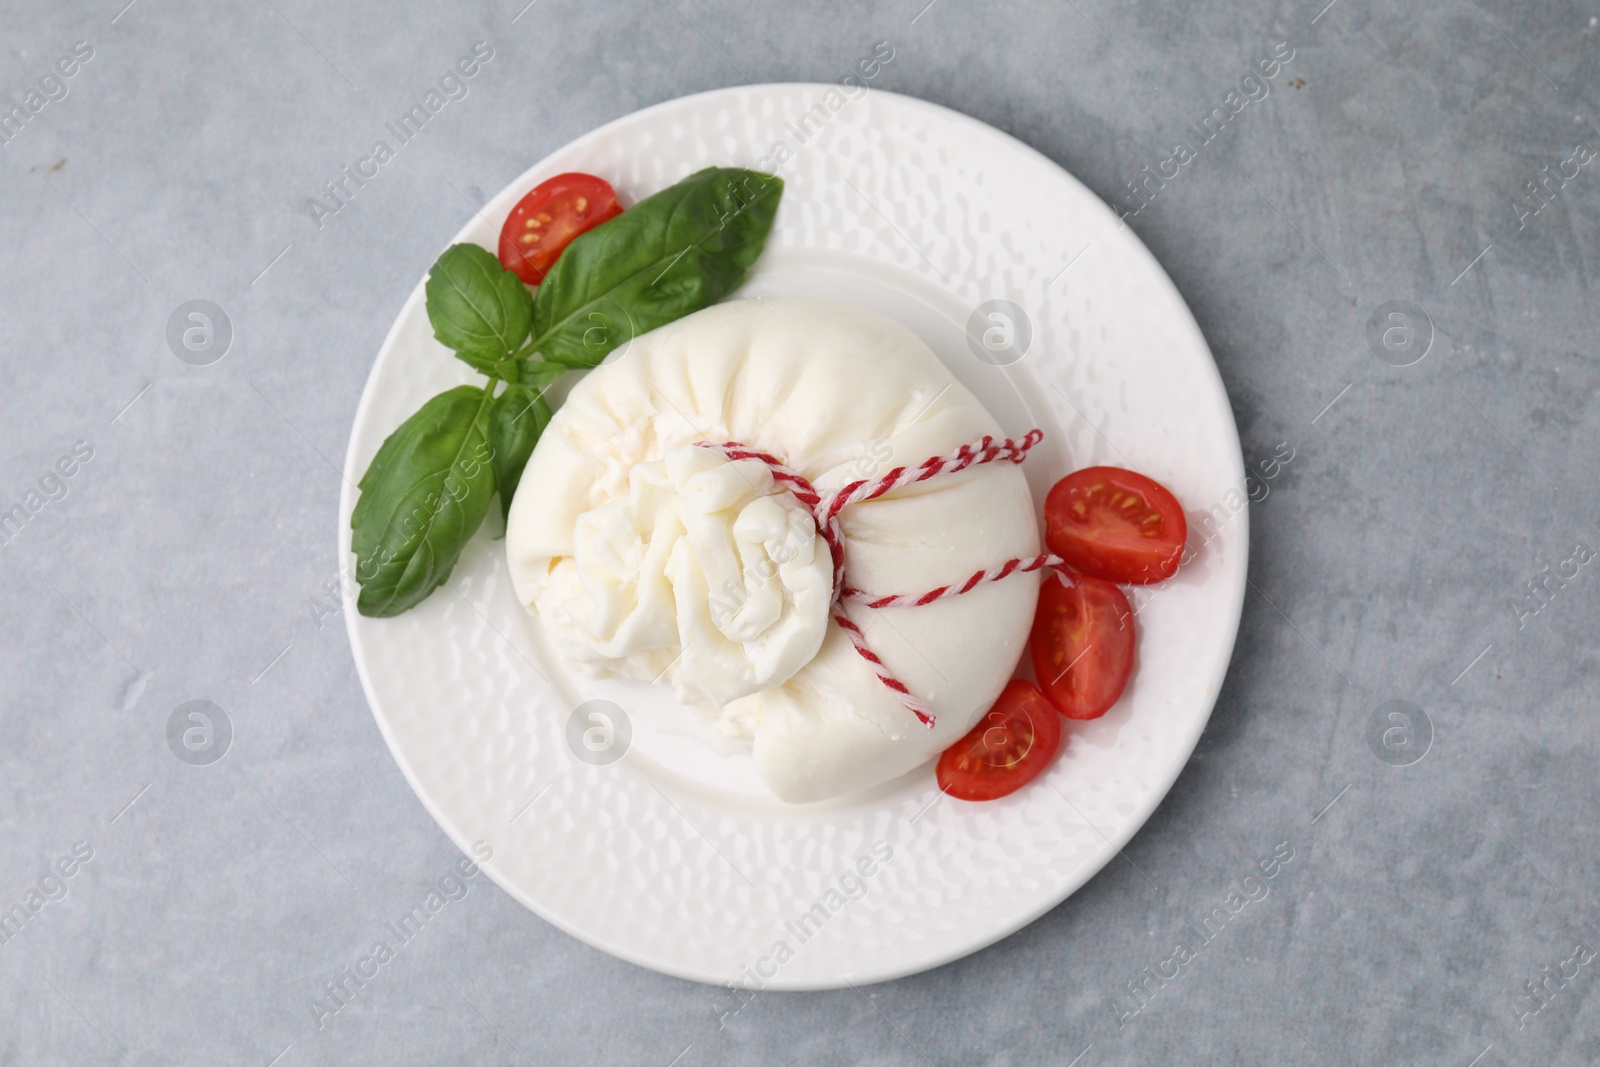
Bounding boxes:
[934,678,1061,800]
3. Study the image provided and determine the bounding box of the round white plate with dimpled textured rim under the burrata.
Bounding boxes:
[339,85,1248,991]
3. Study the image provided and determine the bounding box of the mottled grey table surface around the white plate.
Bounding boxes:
[0,0,1600,1067]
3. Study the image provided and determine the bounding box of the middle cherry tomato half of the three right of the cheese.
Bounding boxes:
[1029,574,1133,718]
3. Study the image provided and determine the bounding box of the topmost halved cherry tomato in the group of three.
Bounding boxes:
[1045,467,1189,585]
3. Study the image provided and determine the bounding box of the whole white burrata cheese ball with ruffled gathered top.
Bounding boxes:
[506,298,1040,803]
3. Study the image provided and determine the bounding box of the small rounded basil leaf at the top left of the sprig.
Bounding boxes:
[424,245,533,376]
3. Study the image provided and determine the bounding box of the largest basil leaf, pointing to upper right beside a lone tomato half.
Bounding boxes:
[533,166,784,366]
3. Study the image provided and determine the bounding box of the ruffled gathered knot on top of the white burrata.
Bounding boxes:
[534,445,834,707]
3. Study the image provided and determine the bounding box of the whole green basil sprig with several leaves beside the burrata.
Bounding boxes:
[350,166,782,616]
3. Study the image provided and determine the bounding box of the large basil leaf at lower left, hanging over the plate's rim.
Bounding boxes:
[350,382,494,617]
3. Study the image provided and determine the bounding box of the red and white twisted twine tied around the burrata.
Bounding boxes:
[698,430,1062,729]
